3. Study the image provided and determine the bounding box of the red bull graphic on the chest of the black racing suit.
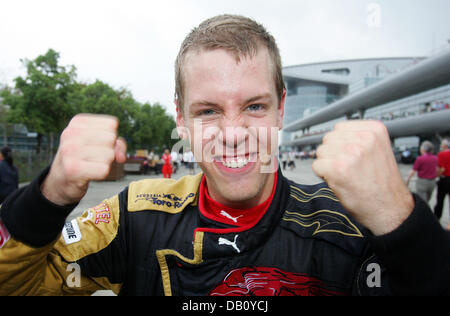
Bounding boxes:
[209,267,344,296]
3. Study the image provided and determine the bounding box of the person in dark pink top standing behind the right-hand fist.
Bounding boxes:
[406,141,438,203]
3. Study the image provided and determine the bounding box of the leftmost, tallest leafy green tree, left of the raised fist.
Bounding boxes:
[3,49,77,153]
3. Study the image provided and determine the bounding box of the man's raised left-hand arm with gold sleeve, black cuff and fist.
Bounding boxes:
[0,115,126,295]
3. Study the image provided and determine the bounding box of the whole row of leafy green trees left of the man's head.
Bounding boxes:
[0,49,176,156]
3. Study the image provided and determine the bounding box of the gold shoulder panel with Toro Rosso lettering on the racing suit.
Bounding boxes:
[128,173,203,214]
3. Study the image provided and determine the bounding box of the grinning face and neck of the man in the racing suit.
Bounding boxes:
[177,49,285,208]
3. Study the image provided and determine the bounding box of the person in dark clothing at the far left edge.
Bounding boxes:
[0,147,19,204]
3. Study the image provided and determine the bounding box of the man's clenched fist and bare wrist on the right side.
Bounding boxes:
[313,121,414,235]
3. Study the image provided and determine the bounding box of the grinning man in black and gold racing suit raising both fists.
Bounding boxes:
[0,15,450,296]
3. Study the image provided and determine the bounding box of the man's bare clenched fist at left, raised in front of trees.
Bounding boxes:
[41,114,126,205]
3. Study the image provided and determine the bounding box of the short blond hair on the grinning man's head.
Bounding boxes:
[175,14,285,110]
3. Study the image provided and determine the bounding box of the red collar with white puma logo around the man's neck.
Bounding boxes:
[196,172,277,233]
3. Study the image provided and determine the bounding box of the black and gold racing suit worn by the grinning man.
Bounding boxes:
[0,168,450,296]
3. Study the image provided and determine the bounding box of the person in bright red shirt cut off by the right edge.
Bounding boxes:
[434,138,450,219]
